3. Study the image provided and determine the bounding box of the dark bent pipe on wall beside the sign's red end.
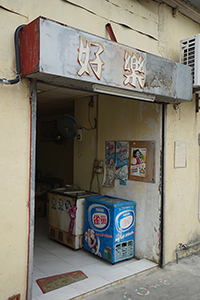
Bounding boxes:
[0,25,26,84]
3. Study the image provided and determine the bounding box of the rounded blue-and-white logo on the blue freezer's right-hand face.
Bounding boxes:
[115,210,135,231]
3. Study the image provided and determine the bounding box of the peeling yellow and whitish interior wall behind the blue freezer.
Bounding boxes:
[74,95,162,262]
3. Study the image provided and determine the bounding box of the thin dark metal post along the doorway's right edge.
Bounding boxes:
[160,104,167,268]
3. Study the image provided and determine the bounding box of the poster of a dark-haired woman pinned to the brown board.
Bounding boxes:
[130,148,147,177]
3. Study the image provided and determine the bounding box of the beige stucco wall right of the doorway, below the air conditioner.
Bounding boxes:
[165,101,200,261]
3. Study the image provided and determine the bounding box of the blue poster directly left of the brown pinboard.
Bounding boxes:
[115,142,129,167]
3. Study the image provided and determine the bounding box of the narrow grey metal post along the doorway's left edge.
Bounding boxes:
[26,80,37,300]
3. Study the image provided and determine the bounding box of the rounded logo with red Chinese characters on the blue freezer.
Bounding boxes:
[88,204,110,231]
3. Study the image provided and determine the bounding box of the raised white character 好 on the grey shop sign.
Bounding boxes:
[77,36,104,80]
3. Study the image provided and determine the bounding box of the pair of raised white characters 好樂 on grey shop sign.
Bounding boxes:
[77,36,146,89]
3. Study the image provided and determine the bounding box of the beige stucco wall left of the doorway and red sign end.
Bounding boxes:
[0,9,30,299]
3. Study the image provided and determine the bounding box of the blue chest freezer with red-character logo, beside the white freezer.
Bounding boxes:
[84,195,136,263]
